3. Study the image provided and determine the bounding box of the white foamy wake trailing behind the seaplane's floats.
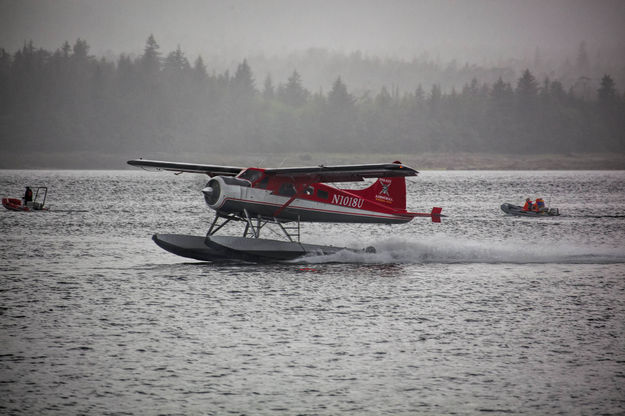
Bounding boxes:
[299,236,625,264]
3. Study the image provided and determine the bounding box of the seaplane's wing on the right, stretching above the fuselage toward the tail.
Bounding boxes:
[265,163,419,182]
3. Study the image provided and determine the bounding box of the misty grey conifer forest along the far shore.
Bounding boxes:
[0,36,625,165]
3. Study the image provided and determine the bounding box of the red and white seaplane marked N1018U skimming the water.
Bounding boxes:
[128,159,442,261]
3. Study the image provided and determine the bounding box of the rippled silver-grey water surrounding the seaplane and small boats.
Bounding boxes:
[0,170,625,415]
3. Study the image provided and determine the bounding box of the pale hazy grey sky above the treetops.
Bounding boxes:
[0,0,625,61]
